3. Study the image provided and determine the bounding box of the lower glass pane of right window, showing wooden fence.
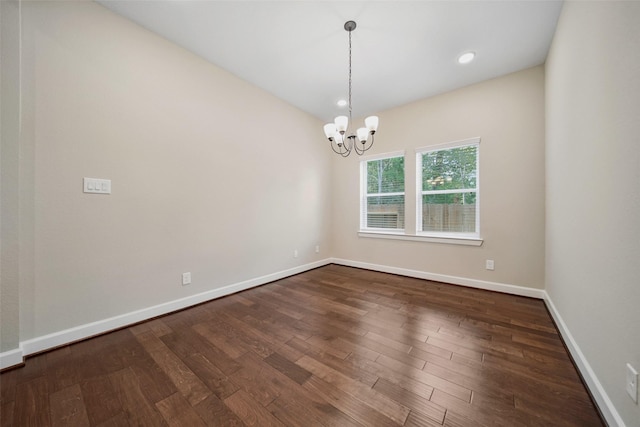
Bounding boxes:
[422,193,476,233]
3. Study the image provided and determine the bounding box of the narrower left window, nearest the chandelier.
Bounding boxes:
[360,153,404,232]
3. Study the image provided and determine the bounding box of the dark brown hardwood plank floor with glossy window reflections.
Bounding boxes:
[0,265,603,427]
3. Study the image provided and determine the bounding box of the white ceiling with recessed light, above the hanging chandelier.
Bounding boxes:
[97,0,562,121]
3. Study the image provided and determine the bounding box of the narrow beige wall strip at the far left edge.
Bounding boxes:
[0,1,20,353]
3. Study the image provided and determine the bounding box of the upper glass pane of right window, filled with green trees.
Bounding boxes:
[422,145,478,190]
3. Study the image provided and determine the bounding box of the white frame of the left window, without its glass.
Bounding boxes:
[360,151,407,235]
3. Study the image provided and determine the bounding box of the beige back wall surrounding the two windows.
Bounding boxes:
[332,66,544,289]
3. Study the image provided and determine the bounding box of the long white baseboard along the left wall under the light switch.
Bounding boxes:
[0,259,330,369]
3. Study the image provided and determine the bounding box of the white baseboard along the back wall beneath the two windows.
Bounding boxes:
[330,258,545,299]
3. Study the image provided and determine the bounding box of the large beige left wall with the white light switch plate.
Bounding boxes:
[10,1,331,341]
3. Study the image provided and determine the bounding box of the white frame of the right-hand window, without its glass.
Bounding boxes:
[415,137,481,241]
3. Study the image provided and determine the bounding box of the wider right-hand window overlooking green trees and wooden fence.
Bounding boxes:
[416,138,480,238]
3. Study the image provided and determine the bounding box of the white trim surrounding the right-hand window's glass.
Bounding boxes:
[416,137,483,242]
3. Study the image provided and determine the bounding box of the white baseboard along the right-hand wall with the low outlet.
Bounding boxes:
[544,291,625,427]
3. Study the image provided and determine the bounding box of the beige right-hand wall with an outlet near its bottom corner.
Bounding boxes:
[546,1,640,427]
